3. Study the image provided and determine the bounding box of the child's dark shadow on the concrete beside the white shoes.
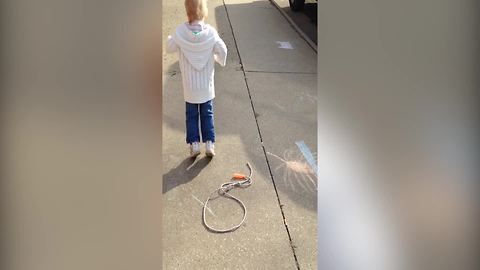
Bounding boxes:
[162,157,212,193]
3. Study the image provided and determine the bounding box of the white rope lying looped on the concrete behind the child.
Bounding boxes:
[203,162,253,233]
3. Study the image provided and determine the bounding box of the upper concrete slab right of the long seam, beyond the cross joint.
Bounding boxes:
[223,0,317,73]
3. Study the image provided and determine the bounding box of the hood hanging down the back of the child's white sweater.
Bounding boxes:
[172,24,217,70]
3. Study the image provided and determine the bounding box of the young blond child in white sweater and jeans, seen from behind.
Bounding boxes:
[167,0,227,157]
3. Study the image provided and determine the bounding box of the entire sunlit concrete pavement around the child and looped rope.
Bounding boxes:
[163,0,317,269]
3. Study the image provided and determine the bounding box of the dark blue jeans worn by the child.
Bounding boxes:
[185,99,215,143]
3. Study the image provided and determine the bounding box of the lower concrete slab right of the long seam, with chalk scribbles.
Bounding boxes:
[247,70,317,269]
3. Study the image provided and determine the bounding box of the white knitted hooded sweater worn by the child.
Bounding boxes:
[167,22,227,104]
